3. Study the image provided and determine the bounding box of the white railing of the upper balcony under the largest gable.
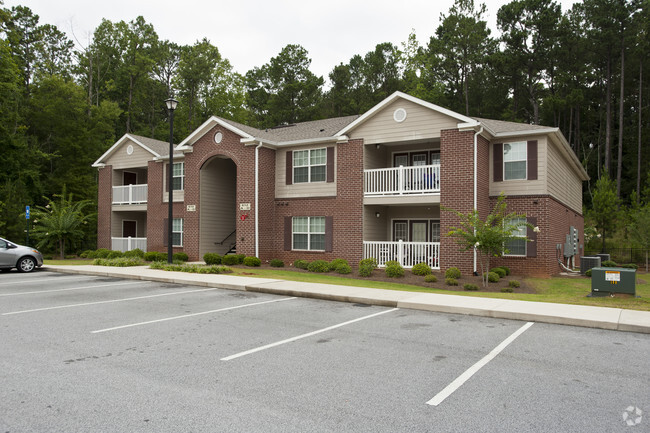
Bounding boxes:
[363,165,440,196]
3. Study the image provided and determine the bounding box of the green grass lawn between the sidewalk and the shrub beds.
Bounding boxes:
[45,259,650,311]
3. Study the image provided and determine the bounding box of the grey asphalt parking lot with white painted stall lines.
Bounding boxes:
[0,271,650,433]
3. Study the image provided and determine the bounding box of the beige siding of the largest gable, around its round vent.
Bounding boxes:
[349,99,458,144]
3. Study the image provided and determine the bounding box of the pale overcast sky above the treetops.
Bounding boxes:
[4,0,576,80]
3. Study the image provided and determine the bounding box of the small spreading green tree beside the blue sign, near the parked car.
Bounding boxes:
[33,188,91,258]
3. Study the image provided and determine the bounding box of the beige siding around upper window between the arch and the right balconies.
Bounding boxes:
[274,143,336,198]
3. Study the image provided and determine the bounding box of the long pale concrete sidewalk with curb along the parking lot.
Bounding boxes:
[43,265,650,334]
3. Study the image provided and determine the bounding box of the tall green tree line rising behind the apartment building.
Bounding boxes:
[0,0,650,251]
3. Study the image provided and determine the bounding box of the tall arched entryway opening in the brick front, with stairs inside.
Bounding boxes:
[199,155,237,258]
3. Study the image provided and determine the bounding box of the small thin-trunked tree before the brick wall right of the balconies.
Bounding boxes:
[443,193,539,287]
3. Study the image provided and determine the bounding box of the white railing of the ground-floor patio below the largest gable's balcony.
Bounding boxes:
[363,241,440,269]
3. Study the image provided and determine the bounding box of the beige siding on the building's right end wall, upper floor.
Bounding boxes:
[548,141,582,212]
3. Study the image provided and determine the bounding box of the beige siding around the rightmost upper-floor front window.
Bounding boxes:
[489,136,548,196]
